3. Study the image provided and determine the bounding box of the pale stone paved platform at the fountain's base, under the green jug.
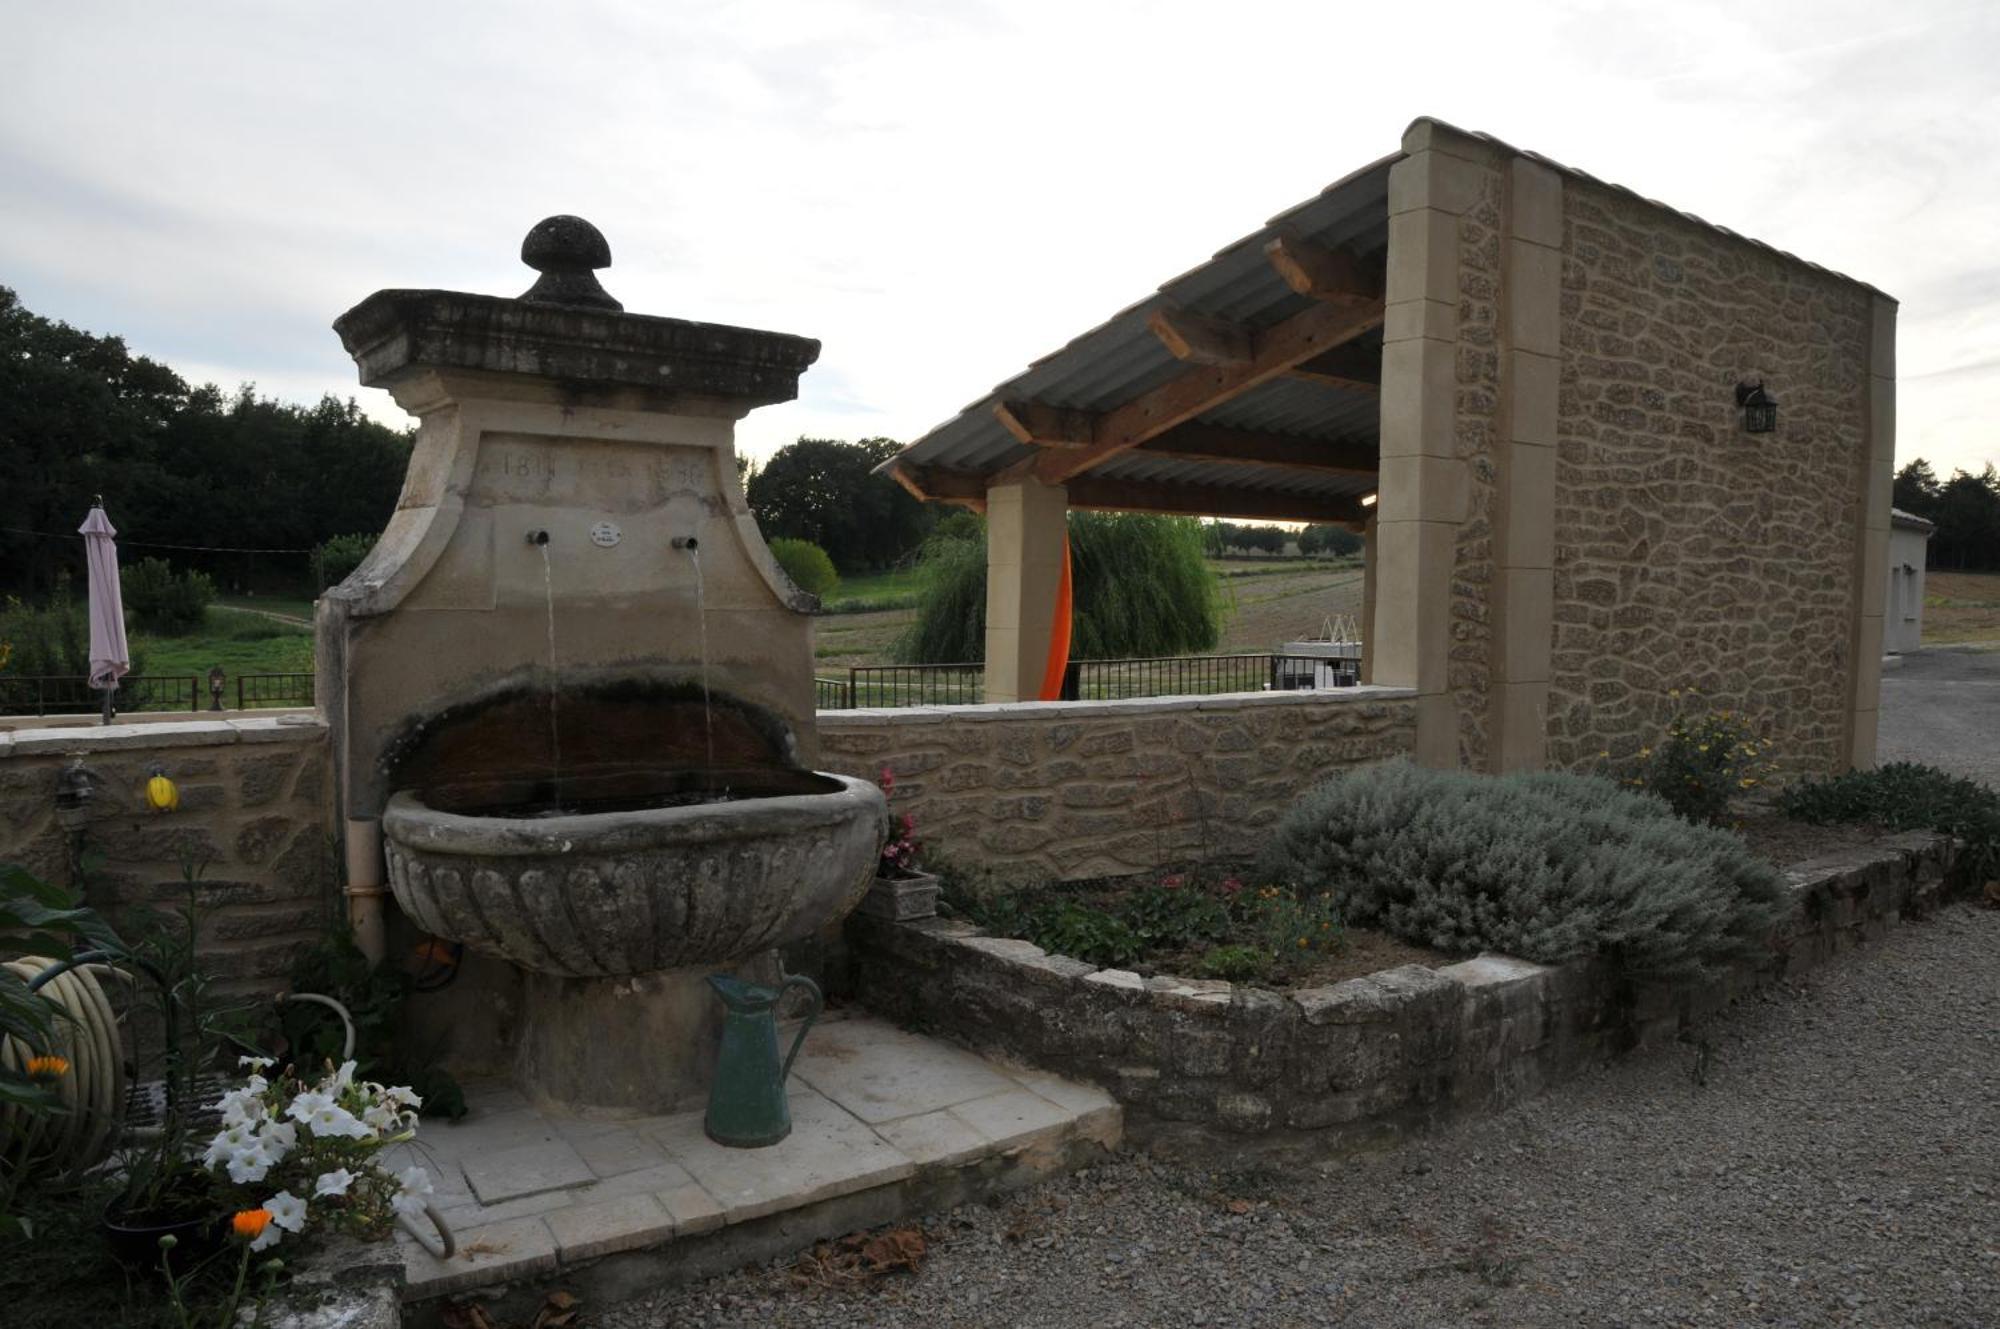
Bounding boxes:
[392,1017,1122,1301]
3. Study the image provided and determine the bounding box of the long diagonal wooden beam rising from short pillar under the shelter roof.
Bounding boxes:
[1032,298,1382,484]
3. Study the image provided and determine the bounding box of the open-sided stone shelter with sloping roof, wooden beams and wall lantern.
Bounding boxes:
[886,118,1896,771]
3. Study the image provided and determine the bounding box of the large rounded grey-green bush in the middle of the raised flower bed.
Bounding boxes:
[1262,763,1786,975]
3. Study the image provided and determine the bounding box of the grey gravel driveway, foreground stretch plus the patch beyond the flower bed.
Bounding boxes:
[588,650,2000,1329]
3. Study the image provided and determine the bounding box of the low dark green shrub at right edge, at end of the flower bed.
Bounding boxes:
[1778,761,2000,883]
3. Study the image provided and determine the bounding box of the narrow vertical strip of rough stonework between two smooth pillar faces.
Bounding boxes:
[1446,158,1506,771]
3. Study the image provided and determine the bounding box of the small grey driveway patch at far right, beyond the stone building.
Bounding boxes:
[1878,646,2000,787]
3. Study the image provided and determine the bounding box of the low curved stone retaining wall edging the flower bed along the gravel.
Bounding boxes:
[848,833,1950,1141]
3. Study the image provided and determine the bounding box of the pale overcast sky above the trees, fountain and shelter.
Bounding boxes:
[0,0,2000,474]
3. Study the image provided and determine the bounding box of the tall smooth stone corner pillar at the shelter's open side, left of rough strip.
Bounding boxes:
[1368,120,1480,767]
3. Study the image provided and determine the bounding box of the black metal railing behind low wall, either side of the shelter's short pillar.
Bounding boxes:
[814,652,1360,711]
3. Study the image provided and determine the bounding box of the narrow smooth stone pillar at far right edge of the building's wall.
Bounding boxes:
[1846,294,1896,767]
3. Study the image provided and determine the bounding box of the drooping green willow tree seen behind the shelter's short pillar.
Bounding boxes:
[896,512,1228,665]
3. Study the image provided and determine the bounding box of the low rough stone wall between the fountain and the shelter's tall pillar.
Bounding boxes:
[820,689,1416,881]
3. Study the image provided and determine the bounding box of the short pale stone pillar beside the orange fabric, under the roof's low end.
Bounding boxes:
[986,478,1070,703]
